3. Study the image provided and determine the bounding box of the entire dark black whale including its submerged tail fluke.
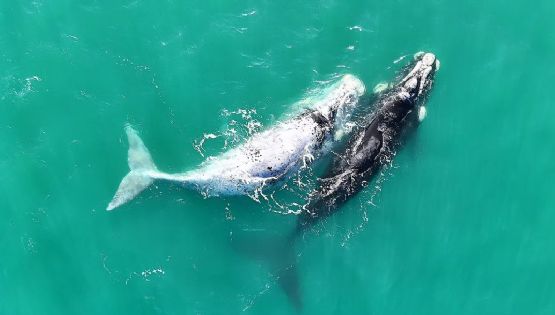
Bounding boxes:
[231,53,439,310]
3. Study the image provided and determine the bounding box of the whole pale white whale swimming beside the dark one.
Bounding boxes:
[107,75,365,210]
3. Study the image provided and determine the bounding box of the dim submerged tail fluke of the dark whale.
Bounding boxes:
[232,233,302,311]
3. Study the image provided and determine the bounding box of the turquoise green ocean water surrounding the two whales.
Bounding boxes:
[0,0,555,315]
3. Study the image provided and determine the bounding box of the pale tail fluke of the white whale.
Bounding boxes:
[106,125,158,211]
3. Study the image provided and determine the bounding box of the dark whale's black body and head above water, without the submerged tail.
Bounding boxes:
[296,53,439,233]
